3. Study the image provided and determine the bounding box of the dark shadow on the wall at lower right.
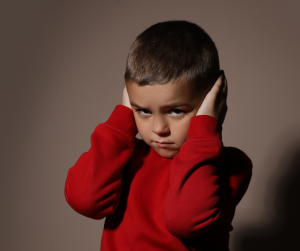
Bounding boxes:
[235,135,300,251]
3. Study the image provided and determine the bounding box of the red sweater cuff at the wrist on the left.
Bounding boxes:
[104,105,138,137]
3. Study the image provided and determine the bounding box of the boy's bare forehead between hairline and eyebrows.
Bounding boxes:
[127,82,194,108]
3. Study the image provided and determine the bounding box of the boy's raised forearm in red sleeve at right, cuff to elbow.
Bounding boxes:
[164,115,224,238]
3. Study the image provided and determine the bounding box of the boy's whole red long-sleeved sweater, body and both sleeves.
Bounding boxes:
[65,105,252,251]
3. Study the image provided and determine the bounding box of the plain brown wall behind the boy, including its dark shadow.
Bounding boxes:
[0,0,300,251]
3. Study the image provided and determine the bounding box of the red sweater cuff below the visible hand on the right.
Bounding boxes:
[187,115,222,140]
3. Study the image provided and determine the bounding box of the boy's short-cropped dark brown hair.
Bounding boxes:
[125,20,220,94]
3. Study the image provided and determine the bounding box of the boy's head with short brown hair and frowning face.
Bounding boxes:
[125,21,220,158]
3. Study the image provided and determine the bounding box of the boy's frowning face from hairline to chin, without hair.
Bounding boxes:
[126,81,204,158]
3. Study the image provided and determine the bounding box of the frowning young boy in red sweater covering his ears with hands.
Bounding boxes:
[65,21,252,251]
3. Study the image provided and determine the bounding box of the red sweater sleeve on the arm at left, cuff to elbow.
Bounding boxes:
[64,105,138,219]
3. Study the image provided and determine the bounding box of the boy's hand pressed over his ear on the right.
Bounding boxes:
[196,71,228,124]
